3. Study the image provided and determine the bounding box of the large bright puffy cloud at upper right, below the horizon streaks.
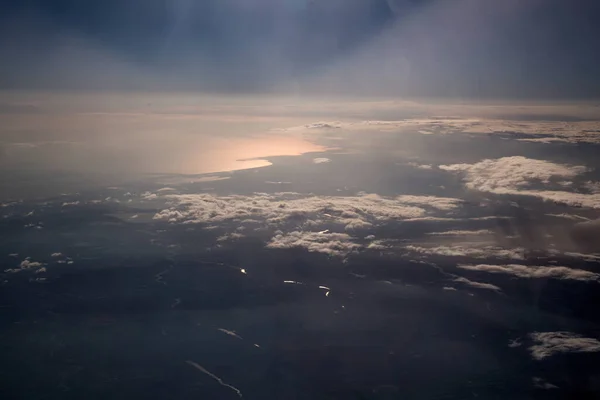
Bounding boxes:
[439,156,600,208]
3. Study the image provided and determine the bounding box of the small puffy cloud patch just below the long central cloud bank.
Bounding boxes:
[267,231,361,257]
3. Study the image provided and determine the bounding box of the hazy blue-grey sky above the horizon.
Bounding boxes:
[0,0,600,99]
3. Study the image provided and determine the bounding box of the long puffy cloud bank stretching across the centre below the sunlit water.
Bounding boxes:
[154,193,440,230]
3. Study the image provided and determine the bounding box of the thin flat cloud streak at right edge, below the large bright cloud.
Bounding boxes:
[457,264,600,281]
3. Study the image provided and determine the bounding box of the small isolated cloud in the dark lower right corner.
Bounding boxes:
[529,332,600,360]
